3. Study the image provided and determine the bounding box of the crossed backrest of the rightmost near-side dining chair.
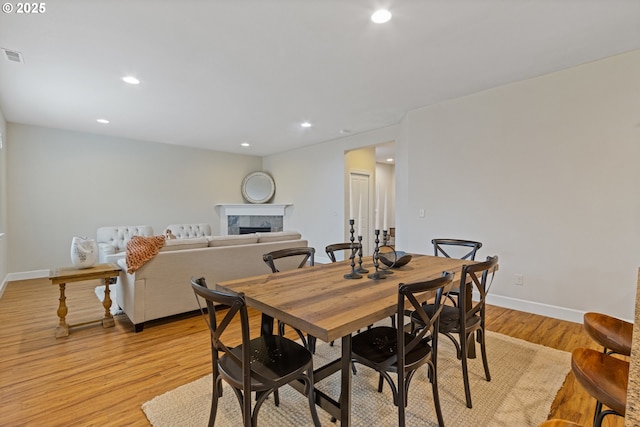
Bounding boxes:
[458,255,498,327]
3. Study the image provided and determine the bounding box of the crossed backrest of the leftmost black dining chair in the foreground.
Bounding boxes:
[191,277,252,390]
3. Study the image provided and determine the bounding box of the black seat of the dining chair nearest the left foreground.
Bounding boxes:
[219,335,312,390]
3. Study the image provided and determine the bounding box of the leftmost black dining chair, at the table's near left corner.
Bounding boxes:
[191,278,320,427]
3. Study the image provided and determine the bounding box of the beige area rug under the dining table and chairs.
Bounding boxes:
[142,333,571,427]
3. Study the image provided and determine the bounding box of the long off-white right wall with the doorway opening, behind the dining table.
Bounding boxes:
[263,51,640,322]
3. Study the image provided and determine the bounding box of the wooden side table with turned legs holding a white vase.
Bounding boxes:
[49,264,121,338]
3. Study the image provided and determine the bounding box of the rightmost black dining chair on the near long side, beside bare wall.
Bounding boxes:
[411,256,498,408]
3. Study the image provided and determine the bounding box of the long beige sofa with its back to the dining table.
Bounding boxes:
[115,231,308,332]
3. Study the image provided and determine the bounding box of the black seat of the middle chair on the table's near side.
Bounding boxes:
[351,326,431,372]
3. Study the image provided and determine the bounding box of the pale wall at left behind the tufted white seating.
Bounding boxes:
[3,123,262,277]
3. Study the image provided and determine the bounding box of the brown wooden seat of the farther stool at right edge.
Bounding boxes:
[584,313,633,356]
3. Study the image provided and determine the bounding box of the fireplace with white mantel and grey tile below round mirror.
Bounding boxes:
[216,203,291,234]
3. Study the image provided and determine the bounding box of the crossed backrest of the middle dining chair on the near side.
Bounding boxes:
[396,271,454,370]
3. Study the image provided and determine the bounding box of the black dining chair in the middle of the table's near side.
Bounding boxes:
[351,272,453,427]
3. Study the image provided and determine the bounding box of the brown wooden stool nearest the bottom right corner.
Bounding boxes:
[571,348,629,427]
